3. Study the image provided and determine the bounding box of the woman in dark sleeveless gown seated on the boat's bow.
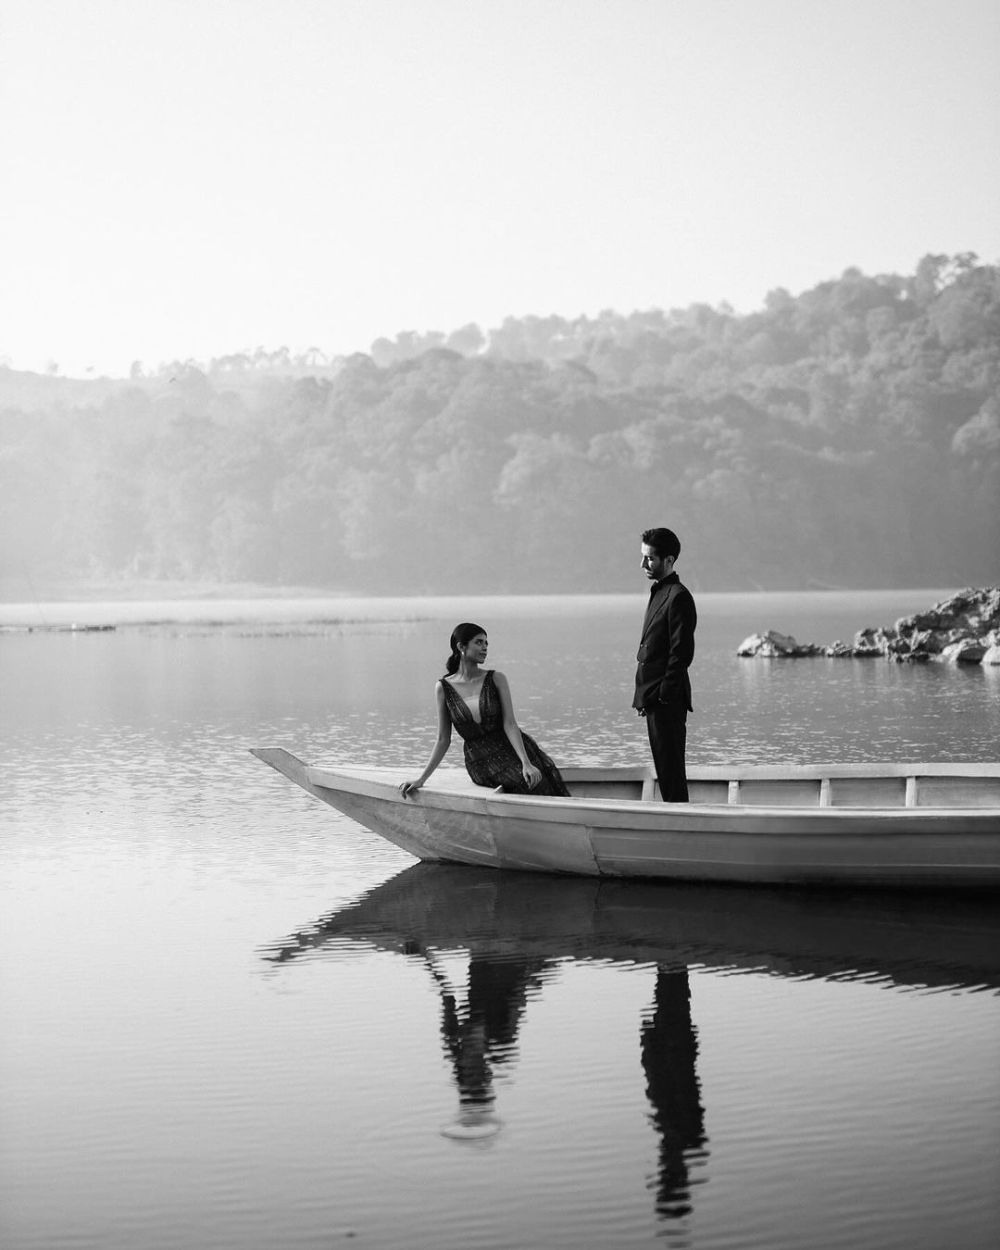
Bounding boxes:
[399,621,569,799]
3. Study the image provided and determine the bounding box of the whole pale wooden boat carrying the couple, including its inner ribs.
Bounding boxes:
[253,748,1000,889]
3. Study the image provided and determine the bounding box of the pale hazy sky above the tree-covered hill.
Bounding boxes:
[0,0,1000,374]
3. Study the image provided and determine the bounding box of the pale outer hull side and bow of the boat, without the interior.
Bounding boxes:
[254,749,1000,889]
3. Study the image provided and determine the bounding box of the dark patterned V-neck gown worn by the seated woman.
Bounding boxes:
[441,669,570,798]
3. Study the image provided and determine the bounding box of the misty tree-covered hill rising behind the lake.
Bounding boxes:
[0,255,1000,598]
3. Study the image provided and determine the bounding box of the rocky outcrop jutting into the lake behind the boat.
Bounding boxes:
[736,586,1000,665]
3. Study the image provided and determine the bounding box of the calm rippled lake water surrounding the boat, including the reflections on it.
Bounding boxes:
[0,589,1000,1250]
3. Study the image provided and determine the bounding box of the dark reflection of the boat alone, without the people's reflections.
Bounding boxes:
[265,863,1000,991]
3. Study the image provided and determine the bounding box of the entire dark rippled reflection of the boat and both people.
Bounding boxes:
[264,863,1000,1220]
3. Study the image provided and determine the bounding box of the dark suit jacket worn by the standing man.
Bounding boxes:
[633,573,698,713]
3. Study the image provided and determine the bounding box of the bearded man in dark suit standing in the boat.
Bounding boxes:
[633,529,698,803]
